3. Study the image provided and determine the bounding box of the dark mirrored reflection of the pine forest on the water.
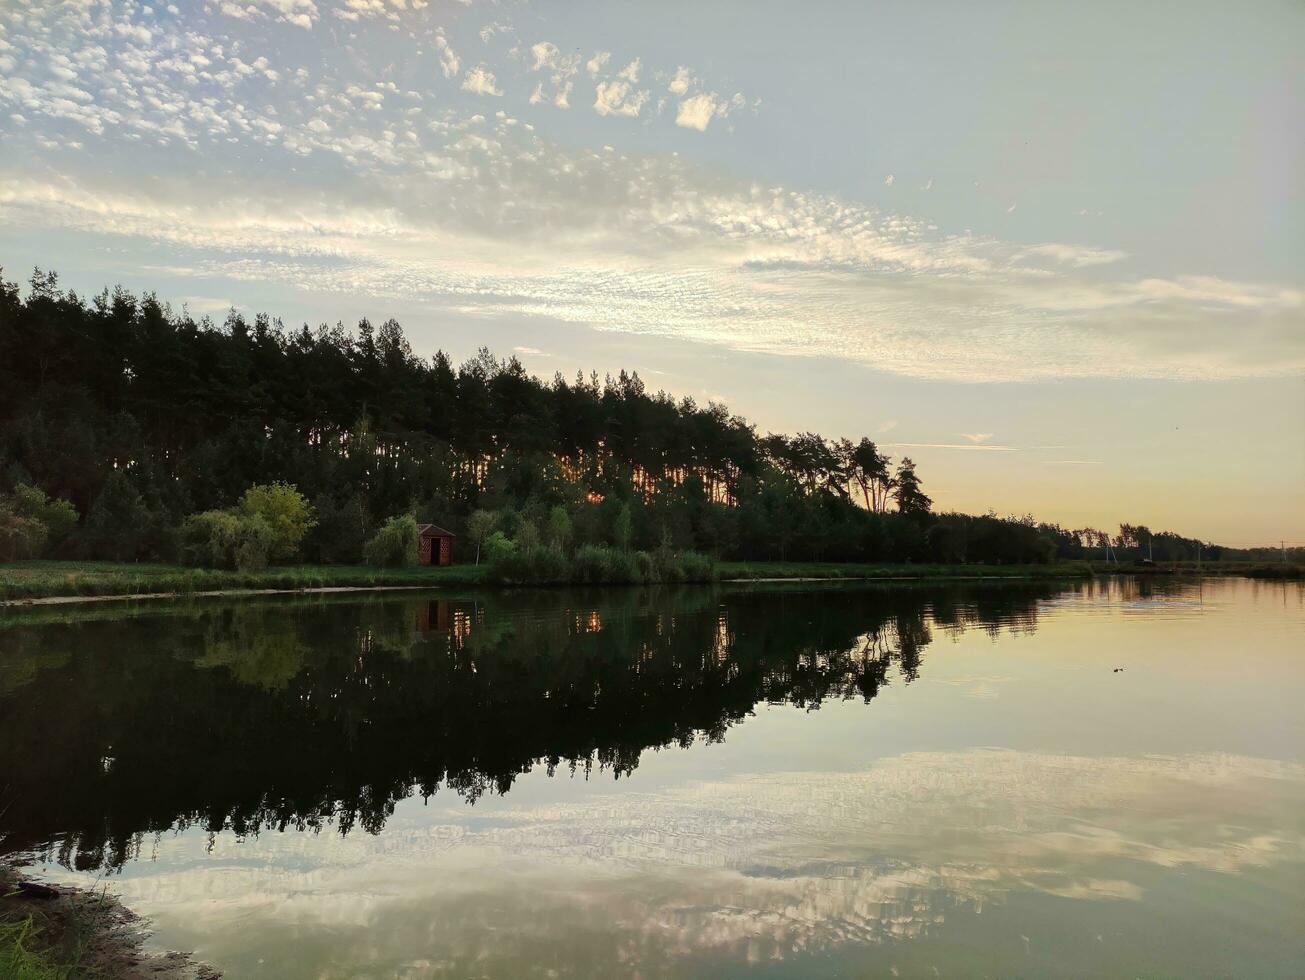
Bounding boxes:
[0,586,1061,869]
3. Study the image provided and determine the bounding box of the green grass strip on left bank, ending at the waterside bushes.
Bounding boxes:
[0,561,485,599]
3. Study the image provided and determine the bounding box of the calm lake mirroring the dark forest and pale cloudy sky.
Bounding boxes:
[0,579,1305,979]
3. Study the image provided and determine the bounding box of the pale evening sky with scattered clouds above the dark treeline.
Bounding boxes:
[0,0,1305,544]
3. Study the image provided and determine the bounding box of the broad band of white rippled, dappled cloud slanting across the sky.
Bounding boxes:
[0,0,1305,381]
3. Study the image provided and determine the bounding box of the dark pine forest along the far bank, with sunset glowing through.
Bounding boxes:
[0,269,1242,562]
